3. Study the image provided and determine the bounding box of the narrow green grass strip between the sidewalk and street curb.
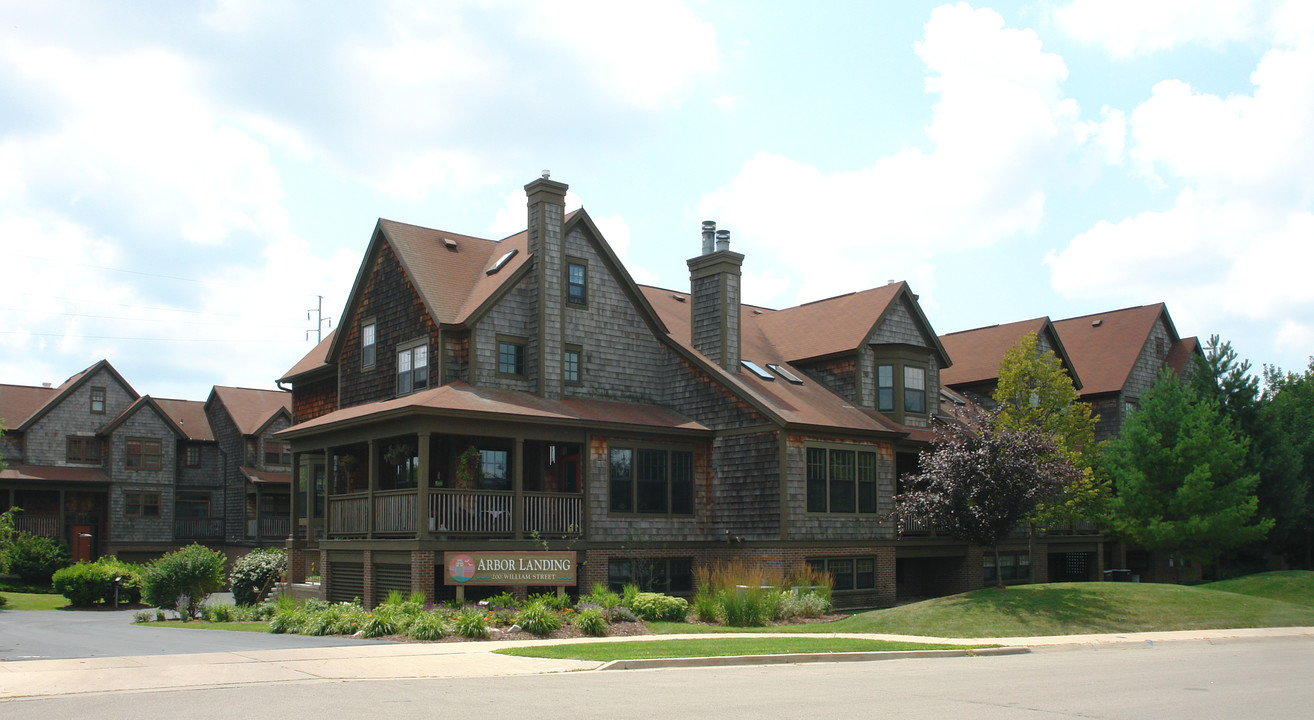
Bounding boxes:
[495,637,993,662]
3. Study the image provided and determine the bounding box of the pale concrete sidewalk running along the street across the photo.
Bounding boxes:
[0,628,1314,699]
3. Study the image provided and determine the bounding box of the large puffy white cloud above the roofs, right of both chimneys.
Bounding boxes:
[698,4,1098,305]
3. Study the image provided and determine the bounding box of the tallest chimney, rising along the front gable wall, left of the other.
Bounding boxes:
[524,171,569,398]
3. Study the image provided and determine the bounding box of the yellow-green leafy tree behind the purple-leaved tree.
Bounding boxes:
[995,332,1109,526]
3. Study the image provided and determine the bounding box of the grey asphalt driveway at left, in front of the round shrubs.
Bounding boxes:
[0,610,385,662]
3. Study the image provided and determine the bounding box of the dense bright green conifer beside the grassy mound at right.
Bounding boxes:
[1104,369,1273,578]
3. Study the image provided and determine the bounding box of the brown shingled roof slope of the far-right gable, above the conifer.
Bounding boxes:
[1054,302,1180,395]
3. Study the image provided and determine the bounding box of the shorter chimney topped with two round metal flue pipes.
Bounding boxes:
[689,221,744,372]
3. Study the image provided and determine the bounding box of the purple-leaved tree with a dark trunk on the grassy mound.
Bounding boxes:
[895,414,1079,587]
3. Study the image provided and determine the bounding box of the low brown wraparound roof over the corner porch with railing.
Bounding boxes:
[277,380,711,438]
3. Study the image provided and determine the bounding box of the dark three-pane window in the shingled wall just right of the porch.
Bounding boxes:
[608,448,694,515]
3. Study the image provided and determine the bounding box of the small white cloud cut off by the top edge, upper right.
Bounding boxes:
[1054,0,1259,59]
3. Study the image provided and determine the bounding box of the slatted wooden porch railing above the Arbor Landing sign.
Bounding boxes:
[326,489,583,539]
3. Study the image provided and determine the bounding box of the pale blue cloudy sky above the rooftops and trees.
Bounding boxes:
[0,0,1314,399]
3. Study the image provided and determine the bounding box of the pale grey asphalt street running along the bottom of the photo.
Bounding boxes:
[0,637,1314,720]
